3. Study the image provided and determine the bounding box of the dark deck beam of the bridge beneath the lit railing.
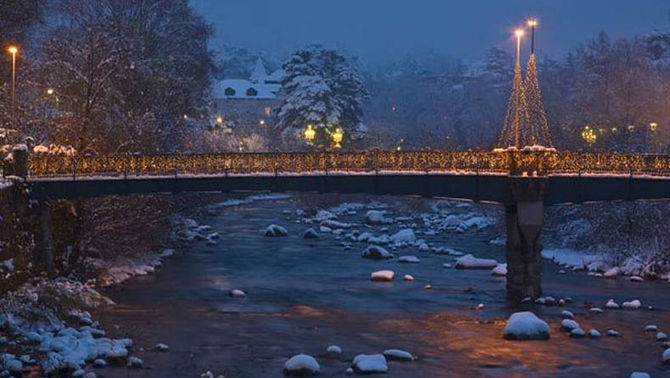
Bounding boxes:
[28,172,670,205]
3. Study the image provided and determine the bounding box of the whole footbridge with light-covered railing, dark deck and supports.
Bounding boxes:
[3,148,670,304]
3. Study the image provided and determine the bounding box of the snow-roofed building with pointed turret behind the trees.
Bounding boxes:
[212,59,284,128]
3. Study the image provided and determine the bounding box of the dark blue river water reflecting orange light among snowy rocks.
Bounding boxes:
[96,198,670,378]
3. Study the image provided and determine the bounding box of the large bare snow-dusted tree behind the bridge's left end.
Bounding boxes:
[41,0,213,153]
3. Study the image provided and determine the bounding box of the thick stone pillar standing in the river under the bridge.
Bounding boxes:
[505,178,545,305]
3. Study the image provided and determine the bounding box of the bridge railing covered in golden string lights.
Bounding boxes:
[29,151,670,177]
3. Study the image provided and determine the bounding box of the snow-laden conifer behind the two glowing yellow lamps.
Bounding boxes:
[277,45,368,145]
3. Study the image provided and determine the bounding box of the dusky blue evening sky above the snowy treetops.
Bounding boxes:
[190,0,670,64]
